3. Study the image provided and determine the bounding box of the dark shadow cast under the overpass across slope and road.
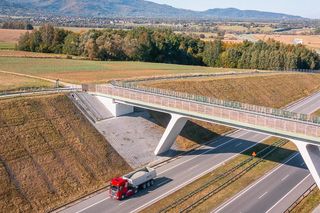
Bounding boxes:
[149,111,307,169]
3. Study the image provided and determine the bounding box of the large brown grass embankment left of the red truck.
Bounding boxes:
[0,95,131,212]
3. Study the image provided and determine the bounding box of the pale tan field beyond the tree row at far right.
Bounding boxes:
[253,34,320,50]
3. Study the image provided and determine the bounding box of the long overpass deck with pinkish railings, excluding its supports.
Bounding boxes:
[88,85,320,144]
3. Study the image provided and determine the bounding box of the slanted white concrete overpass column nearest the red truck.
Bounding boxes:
[154,114,188,155]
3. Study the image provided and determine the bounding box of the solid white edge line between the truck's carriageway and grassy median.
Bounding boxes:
[130,138,265,213]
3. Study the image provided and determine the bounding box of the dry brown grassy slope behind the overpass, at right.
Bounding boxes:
[145,74,320,108]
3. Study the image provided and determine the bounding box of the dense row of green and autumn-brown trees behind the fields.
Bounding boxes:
[18,25,320,69]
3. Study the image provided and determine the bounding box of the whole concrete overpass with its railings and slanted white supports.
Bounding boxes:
[83,82,320,187]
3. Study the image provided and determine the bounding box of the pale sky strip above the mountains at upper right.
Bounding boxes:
[149,0,320,19]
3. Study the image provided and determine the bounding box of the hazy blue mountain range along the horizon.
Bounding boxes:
[0,0,302,20]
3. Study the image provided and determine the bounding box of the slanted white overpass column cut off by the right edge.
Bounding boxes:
[293,141,320,188]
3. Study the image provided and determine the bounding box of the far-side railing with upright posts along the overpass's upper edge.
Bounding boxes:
[111,81,320,124]
